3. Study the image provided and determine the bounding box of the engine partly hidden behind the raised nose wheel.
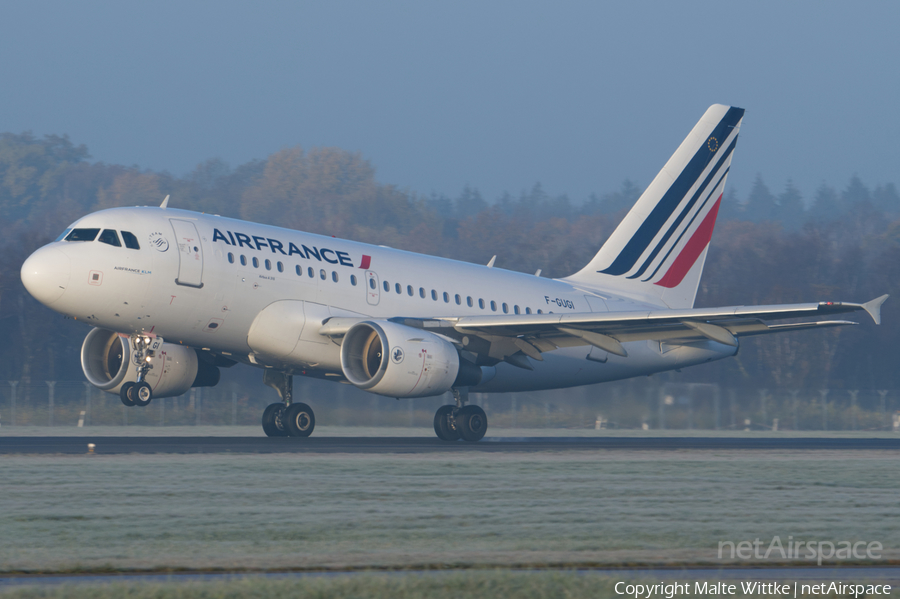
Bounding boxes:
[81,329,219,398]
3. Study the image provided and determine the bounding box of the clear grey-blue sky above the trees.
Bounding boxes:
[0,0,900,203]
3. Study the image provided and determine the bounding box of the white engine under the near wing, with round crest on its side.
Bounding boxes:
[341,320,481,397]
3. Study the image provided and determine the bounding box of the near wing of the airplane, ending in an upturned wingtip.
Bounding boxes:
[319,295,888,365]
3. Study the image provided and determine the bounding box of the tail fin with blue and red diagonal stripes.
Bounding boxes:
[566,104,744,308]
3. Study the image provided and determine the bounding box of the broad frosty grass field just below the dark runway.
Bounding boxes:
[0,450,900,572]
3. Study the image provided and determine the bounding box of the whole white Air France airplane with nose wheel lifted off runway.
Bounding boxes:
[21,105,887,441]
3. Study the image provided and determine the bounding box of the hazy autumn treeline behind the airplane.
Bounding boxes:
[0,133,900,389]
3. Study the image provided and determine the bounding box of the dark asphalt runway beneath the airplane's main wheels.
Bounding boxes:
[0,435,900,455]
